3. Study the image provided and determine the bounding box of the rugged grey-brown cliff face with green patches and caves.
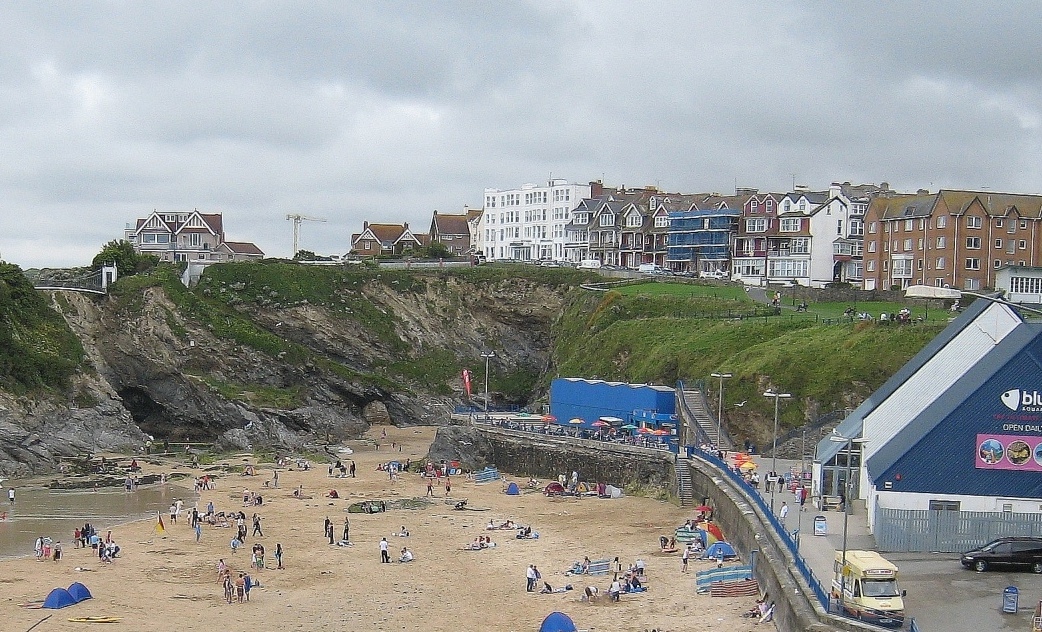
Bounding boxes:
[0,267,567,474]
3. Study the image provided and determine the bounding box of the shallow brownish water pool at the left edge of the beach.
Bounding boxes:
[0,484,196,557]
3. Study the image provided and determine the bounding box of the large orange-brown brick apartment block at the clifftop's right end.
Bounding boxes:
[864,189,1042,290]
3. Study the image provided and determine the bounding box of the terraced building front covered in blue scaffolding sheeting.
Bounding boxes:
[666,208,741,273]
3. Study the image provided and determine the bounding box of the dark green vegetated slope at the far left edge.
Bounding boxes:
[0,262,83,394]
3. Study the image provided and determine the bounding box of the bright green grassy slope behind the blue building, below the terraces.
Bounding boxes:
[554,287,946,438]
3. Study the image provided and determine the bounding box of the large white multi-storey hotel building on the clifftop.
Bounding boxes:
[474,179,591,261]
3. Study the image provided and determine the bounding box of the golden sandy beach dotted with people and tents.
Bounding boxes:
[0,427,773,632]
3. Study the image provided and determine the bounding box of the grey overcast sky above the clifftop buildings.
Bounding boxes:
[0,0,1042,268]
